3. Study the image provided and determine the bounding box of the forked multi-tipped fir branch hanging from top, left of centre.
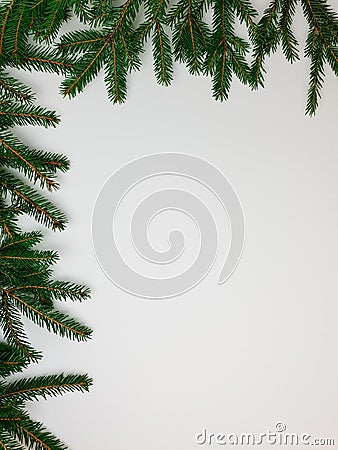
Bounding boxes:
[60,0,141,103]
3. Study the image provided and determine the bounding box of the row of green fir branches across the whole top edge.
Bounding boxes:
[0,0,338,115]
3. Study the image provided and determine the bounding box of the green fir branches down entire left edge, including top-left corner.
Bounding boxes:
[0,11,92,450]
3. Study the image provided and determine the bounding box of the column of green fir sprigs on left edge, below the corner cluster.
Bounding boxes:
[0,56,91,450]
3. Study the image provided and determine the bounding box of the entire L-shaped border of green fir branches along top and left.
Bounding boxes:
[0,0,338,450]
